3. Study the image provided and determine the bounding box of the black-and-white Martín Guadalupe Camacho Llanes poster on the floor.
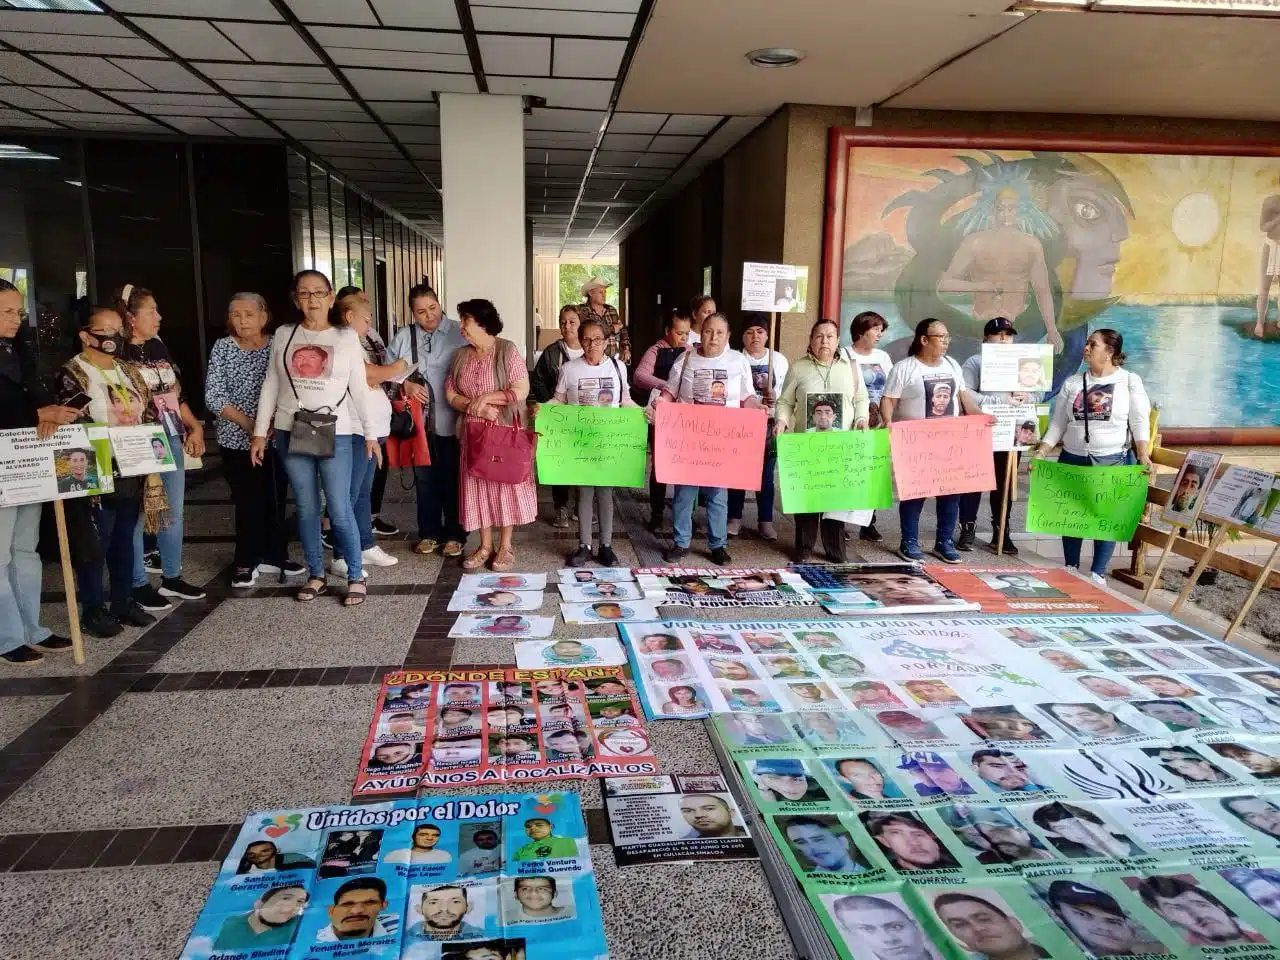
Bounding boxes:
[603,771,755,867]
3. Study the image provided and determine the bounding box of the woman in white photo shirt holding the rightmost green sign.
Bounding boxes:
[1029,328,1151,586]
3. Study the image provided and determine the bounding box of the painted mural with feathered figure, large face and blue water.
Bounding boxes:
[828,145,1280,426]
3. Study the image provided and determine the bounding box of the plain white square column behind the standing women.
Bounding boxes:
[440,93,524,358]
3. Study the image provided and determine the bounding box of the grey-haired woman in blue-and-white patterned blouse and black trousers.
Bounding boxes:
[205,293,306,588]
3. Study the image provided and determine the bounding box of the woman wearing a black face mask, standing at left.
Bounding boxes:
[56,307,156,636]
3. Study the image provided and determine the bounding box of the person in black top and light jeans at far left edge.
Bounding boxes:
[0,280,79,664]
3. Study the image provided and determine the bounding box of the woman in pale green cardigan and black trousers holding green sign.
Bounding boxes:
[773,320,870,563]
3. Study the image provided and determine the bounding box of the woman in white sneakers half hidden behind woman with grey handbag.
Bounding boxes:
[329,289,408,576]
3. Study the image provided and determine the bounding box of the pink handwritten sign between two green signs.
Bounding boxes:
[653,403,762,490]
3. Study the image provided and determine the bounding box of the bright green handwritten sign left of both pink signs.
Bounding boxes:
[535,403,649,486]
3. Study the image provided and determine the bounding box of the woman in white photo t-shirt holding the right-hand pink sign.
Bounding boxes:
[881,317,982,563]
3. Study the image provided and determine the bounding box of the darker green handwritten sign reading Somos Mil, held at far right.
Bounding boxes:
[1027,460,1147,540]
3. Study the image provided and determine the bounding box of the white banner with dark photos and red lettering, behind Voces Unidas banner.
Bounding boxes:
[635,567,814,608]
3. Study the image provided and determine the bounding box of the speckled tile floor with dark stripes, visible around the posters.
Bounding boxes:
[0,463,1259,960]
